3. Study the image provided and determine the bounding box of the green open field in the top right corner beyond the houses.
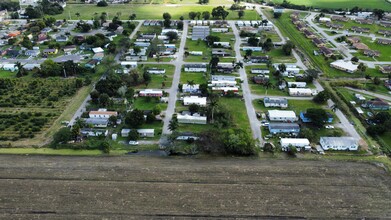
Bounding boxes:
[270,0,391,11]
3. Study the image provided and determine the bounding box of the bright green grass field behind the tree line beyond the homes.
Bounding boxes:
[54,4,259,20]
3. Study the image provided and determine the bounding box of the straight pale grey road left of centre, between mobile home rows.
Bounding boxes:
[160,21,189,134]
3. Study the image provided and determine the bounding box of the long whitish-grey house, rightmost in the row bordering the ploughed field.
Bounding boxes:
[319,137,358,150]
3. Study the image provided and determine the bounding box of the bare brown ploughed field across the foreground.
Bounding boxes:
[0,155,391,219]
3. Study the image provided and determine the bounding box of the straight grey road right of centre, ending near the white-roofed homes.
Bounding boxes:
[229,21,263,146]
